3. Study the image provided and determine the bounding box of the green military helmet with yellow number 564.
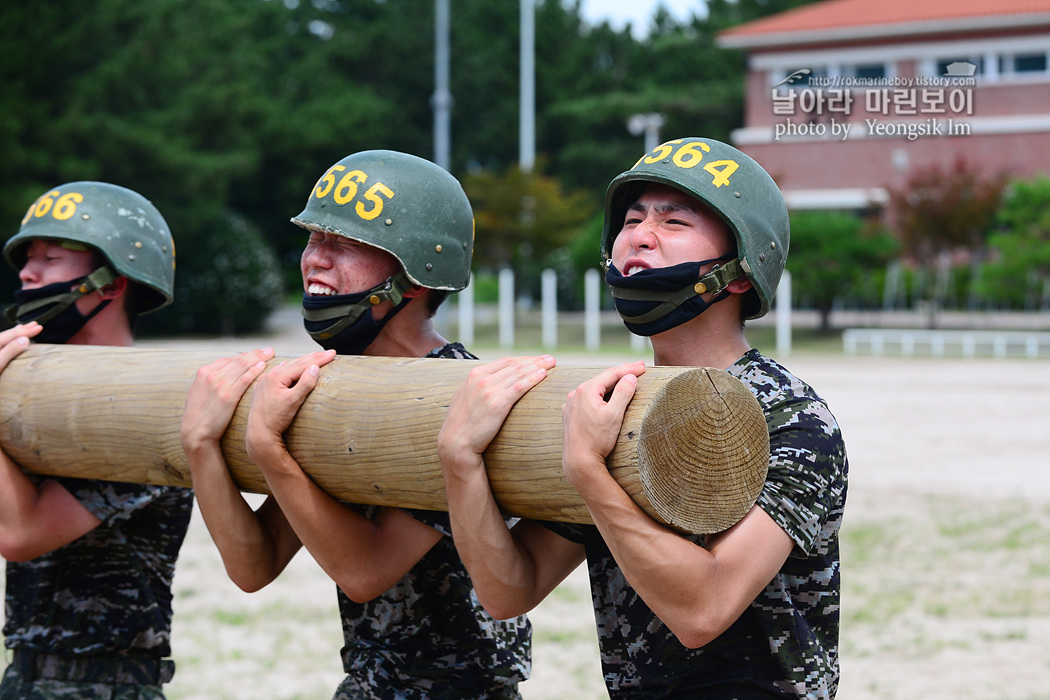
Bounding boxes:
[602,137,790,318]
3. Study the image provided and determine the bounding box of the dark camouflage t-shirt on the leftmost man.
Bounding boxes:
[3,479,193,658]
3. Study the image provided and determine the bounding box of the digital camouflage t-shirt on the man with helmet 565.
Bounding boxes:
[335,343,531,700]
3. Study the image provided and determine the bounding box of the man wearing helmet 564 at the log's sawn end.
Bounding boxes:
[438,137,848,700]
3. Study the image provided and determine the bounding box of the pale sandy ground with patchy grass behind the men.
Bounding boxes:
[2,321,1050,700]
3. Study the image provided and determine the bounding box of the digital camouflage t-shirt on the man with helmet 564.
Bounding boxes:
[548,349,848,700]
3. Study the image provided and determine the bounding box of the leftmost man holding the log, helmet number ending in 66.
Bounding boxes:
[0,182,193,700]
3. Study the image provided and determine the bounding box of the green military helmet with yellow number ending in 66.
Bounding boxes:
[3,182,175,313]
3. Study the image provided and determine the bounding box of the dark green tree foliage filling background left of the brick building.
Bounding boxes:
[0,0,814,332]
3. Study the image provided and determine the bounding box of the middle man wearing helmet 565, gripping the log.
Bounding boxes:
[183,150,530,700]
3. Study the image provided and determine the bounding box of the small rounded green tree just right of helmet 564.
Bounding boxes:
[788,211,899,332]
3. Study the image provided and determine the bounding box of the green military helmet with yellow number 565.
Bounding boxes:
[292,150,474,292]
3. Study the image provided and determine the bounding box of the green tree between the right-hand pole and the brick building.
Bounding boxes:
[538,3,744,193]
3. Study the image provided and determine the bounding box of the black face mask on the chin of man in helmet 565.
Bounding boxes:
[302,273,412,355]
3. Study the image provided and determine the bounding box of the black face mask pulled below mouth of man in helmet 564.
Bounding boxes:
[605,254,743,336]
